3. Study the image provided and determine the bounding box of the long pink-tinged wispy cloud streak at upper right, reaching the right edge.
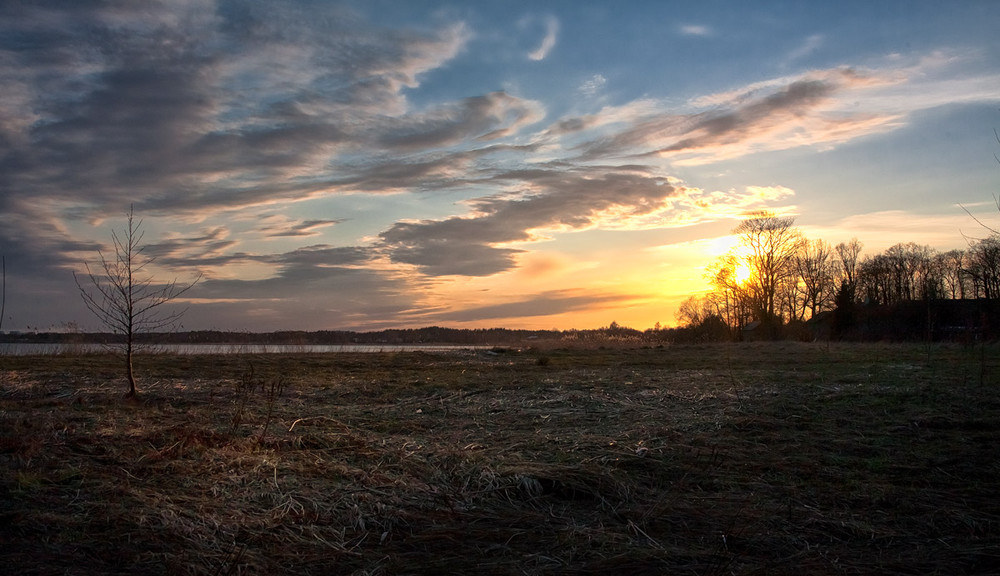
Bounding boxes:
[558,59,1000,165]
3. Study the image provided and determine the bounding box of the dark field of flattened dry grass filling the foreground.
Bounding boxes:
[0,343,1000,575]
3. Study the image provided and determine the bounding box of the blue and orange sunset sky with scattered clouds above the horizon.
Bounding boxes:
[0,0,1000,332]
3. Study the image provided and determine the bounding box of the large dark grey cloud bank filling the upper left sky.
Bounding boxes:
[0,2,472,214]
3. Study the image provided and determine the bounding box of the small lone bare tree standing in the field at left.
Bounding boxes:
[73,206,201,397]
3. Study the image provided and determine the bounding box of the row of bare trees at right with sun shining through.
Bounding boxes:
[677,211,1000,340]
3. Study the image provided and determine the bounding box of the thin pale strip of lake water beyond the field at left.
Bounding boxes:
[0,343,490,356]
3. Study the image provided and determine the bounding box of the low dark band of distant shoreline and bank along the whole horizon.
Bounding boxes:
[0,298,1000,347]
